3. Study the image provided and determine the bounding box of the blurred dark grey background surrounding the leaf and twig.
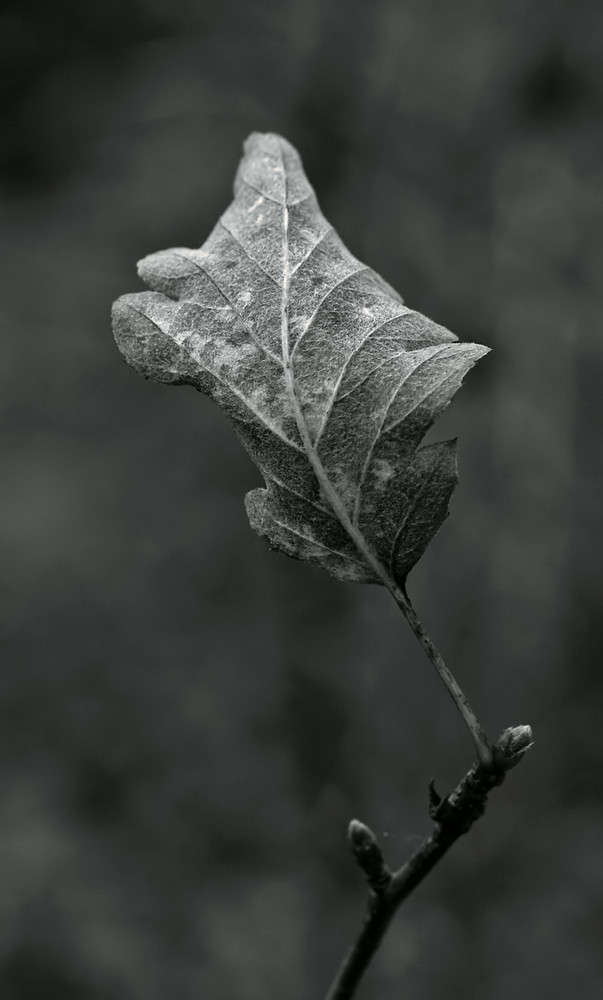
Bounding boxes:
[0,0,603,1000]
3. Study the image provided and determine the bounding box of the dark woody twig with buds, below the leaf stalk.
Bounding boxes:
[326,726,532,1000]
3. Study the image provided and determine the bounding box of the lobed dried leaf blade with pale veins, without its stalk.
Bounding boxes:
[113,133,487,587]
